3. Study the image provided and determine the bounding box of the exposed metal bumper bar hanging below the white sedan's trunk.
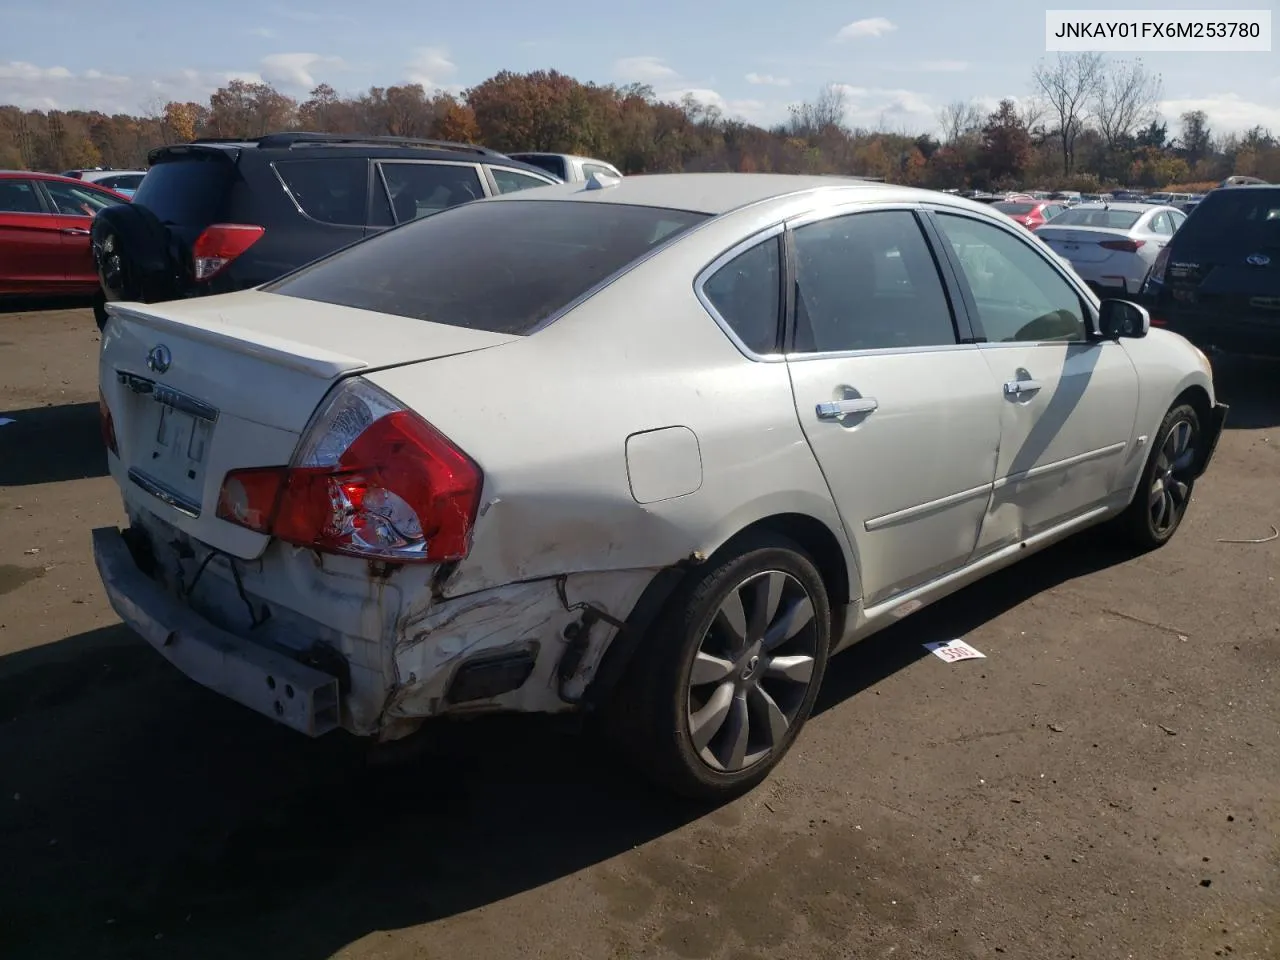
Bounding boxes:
[93,527,339,737]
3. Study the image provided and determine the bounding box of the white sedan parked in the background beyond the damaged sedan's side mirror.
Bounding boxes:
[1036,204,1187,297]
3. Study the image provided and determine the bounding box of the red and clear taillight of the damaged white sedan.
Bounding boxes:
[218,379,484,563]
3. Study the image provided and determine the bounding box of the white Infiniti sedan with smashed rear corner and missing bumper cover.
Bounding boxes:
[93,174,1226,796]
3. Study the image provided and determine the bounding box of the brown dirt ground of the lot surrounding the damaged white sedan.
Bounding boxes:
[0,310,1280,960]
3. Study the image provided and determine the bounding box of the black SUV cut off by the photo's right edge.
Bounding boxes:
[1143,184,1280,357]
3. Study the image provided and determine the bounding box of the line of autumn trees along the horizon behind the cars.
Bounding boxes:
[0,54,1280,192]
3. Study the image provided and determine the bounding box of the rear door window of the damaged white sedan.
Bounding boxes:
[794,210,956,353]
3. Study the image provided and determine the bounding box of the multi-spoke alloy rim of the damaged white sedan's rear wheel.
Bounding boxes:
[687,570,818,773]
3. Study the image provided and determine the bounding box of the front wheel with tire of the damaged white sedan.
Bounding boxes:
[1117,403,1203,552]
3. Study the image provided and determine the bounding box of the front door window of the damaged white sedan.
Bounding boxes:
[937,214,1087,343]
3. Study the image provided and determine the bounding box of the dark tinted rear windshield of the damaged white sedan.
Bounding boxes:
[264,200,707,334]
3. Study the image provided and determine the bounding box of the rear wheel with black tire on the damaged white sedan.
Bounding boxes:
[617,536,831,801]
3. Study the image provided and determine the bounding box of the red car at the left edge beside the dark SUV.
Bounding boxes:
[0,170,129,312]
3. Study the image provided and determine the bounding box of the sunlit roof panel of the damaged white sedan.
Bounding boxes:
[481,173,931,215]
